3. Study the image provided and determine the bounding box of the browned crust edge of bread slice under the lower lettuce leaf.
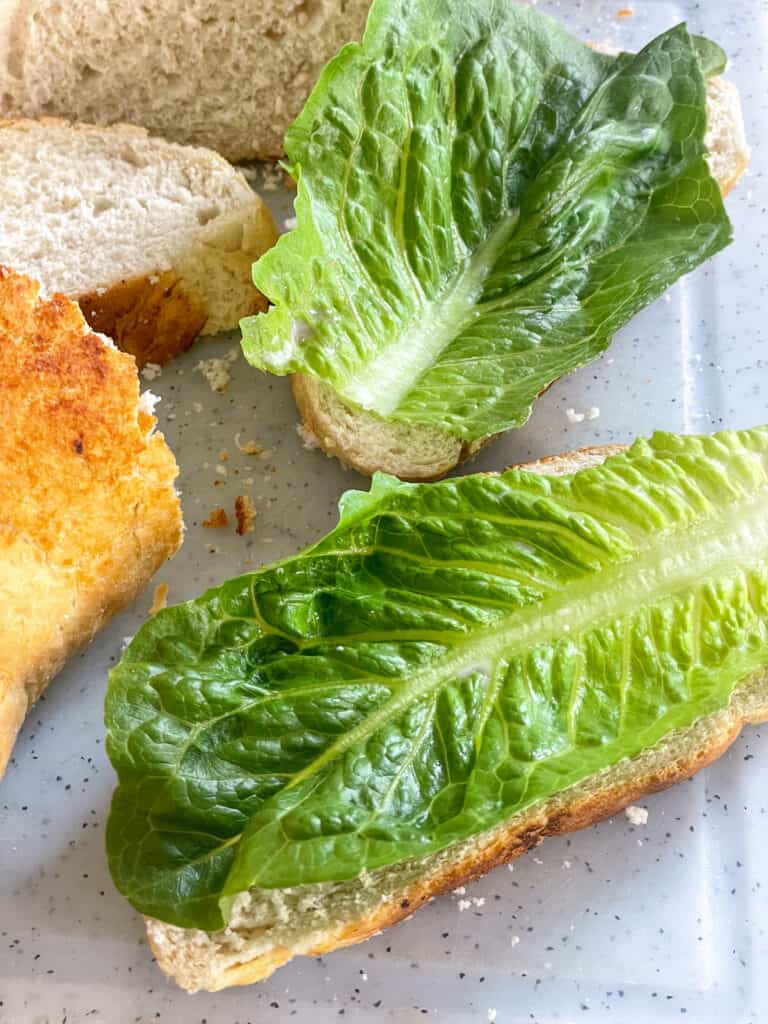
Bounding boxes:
[146,444,768,991]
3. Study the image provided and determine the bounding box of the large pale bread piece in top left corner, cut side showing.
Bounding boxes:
[0,0,370,161]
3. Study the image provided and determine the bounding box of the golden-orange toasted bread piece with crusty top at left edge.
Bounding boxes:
[0,266,182,776]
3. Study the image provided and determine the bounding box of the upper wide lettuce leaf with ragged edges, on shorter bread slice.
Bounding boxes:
[243,0,731,439]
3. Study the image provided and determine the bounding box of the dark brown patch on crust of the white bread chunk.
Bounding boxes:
[78,270,208,368]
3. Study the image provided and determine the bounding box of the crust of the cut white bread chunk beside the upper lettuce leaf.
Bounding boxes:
[0,118,279,368]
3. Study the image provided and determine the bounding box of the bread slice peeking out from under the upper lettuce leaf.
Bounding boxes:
[293,78,750,480]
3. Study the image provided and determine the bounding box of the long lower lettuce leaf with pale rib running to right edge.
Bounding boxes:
[106,427,768,930]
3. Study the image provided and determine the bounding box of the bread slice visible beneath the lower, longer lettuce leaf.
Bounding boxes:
[146,445,768,991]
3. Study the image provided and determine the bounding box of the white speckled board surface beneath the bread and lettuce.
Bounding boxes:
[0,0,768,1024]
